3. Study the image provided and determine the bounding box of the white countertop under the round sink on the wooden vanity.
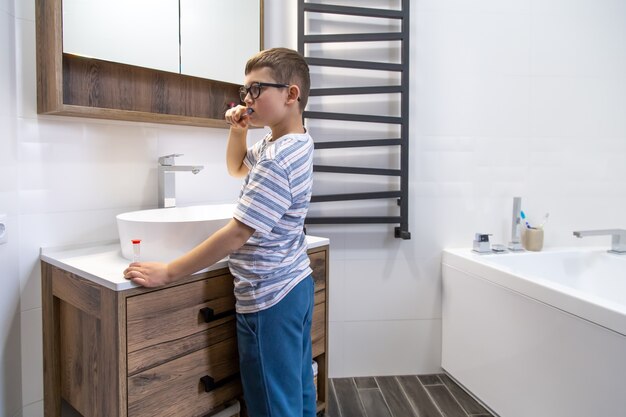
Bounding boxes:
[40,236,329,291]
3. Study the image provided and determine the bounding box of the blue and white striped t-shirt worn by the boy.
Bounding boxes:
[229,133,313,313]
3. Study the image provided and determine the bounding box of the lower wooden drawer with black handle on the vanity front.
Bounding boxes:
[128,328,241,417]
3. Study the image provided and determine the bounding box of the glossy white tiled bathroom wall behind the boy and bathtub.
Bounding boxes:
[0,0,626,417]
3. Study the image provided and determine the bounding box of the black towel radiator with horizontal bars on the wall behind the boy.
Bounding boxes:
[298,0,411,239]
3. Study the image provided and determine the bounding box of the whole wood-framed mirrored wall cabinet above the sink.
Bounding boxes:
[36,0,263,128]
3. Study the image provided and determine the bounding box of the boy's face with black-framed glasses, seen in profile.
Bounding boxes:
[244,67,289,126]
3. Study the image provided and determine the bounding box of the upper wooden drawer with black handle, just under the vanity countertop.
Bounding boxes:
[126,274,235,353]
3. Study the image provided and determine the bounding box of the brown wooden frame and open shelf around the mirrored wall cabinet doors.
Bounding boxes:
[35,0,243,128]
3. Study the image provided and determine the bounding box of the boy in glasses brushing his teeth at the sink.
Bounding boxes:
[124,48,316,417]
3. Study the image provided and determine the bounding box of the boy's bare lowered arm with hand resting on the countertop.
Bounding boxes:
[124,219,254,287]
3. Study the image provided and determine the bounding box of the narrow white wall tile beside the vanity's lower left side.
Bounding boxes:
[21,308,43,406]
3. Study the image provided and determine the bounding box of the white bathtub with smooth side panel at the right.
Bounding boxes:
[442,249,626,417]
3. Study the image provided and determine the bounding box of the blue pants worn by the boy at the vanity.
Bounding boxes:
[237,276,316,417]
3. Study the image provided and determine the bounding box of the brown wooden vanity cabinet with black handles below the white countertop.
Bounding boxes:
[42,246,328,417]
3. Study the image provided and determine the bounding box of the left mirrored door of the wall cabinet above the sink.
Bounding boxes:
[63,0,179,72]
